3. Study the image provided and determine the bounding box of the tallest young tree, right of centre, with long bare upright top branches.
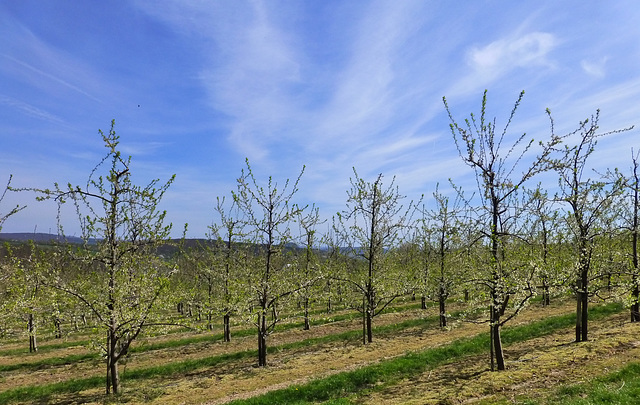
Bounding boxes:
[443,90,560,370]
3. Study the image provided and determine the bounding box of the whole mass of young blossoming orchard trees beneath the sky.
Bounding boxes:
[0,92,640,393]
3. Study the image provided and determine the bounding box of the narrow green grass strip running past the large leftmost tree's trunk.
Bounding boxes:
[0,306,438,404]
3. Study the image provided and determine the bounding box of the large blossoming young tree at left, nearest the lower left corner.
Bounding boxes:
[36,121,174,394]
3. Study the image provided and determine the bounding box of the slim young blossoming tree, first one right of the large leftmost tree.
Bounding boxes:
[233,159,304,367]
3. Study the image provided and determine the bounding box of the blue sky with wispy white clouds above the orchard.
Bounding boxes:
[0,0,640,238]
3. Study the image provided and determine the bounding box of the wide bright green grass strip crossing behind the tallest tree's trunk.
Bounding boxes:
[226,303,624,405]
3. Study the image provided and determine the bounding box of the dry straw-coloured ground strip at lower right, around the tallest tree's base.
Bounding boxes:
[354,312,640,405]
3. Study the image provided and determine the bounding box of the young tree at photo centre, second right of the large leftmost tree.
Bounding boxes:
[336,168,411,344]
